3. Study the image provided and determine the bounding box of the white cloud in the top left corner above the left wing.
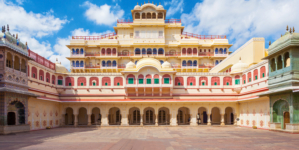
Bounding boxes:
[0,0,67,58]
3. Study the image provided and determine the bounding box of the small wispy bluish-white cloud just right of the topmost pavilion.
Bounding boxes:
[164,0,184,17]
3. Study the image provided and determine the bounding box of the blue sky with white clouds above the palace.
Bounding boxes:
[0,0,299,68]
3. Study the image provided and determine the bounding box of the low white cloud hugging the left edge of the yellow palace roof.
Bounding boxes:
[49,28,112,69]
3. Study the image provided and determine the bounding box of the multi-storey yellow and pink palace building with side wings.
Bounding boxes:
[0,3,299,134]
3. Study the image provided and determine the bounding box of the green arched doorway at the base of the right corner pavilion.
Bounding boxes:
[272,100,291,129]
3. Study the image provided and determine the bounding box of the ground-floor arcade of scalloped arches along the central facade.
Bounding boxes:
[62,105,237,126]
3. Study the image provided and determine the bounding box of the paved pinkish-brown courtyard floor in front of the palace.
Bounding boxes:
[0,126,299,150]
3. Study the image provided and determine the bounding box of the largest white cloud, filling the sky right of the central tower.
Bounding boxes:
[181,0,299,50]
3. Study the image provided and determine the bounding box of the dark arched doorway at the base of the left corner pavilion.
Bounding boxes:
[7,101,26,125]
